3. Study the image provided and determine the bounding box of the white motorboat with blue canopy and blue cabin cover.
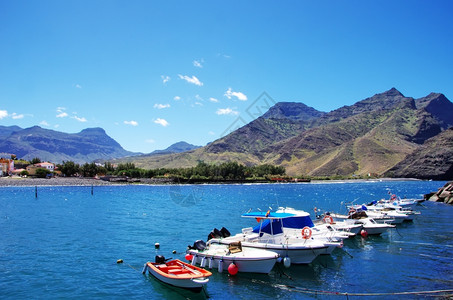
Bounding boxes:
[208,211,329,264]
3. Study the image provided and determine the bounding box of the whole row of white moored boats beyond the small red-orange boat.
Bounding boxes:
[143,192,420,292]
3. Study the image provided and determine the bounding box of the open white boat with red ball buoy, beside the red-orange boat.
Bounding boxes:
[186,239,279,274]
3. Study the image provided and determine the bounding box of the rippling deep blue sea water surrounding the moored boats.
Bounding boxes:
[0,181,453,299]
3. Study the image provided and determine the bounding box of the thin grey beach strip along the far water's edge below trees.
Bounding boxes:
[0,177,428,187]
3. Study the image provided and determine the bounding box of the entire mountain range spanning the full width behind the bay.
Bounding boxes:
[0,88,453,179]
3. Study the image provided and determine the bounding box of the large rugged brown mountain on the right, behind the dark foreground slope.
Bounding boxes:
[122,88,453,178]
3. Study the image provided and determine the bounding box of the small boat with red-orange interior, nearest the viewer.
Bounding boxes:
[142,255,212,293]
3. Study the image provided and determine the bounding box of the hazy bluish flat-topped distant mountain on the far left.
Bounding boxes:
[0,126,136,163]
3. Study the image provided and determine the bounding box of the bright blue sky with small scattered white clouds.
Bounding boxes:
[0,0,453,153]
